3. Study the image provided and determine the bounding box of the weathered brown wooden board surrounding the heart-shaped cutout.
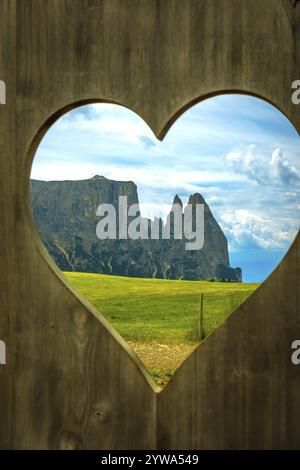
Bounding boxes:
[0,0,300,449]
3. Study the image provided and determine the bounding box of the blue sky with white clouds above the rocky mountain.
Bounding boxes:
[31,95,300,282]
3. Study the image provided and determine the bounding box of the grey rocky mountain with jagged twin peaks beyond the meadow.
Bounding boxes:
[31,176,242,281]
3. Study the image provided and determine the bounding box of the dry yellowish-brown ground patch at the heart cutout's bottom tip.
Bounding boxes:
[128,341,197,387]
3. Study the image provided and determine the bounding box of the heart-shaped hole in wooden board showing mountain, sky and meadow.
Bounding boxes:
[31,95,300,386]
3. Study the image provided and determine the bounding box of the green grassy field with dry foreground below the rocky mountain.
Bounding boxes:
[65,272,258,386]
